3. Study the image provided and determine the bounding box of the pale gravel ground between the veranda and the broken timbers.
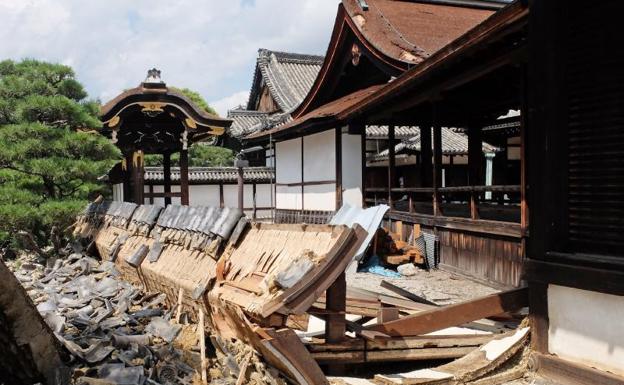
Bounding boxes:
[347,269,498,305]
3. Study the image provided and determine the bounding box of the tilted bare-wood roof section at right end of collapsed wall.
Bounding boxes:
[212,223,366,319]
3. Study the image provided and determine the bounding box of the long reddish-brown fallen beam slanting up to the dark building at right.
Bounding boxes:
[367,288,529,336]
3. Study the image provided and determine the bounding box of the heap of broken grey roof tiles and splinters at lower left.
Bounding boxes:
[7,249,284,385]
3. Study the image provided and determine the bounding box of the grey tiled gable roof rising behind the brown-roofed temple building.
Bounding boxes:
[247,49,323,112]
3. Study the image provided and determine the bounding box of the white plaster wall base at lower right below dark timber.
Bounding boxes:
[548,285,624,375]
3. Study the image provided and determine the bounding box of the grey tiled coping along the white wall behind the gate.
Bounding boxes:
[145,167,274,184]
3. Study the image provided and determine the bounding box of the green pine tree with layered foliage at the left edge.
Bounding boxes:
[0,60,120,248]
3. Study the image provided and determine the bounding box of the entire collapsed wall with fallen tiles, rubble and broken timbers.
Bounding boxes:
[1,202,527,385]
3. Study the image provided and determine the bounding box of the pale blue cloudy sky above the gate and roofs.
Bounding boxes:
[0,0,339,114]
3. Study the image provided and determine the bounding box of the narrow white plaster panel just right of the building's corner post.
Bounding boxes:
[342,134,362,207]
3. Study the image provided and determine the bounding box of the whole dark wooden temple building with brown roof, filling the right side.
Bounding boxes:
[241,0,624,384]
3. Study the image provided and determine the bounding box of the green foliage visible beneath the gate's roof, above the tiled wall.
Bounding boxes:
[145,143,234,167]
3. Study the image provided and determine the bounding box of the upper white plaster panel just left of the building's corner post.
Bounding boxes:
[304,130,336,182]
